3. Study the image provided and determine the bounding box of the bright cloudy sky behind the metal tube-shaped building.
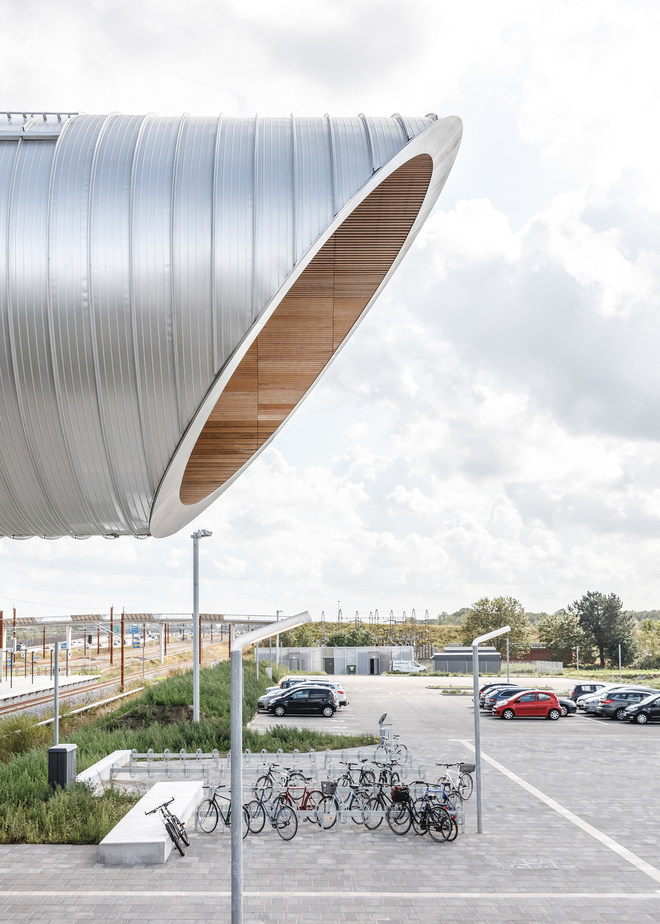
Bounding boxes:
[0,0,660,618]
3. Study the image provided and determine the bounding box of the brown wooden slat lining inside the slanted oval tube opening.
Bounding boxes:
[180,154,432,504]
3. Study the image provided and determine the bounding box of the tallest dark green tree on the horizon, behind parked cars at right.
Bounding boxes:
[568,590,637,667]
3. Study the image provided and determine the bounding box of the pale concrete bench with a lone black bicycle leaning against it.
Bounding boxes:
[99,780,203,866]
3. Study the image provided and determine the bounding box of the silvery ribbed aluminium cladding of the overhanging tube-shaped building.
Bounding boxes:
[0,113,460,536]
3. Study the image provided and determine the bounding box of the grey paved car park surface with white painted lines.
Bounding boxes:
[0,677,660,922]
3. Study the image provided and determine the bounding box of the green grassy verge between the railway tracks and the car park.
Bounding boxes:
[0,661,376,844]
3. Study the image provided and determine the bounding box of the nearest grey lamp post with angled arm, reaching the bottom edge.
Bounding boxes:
[230,611,312,924]
